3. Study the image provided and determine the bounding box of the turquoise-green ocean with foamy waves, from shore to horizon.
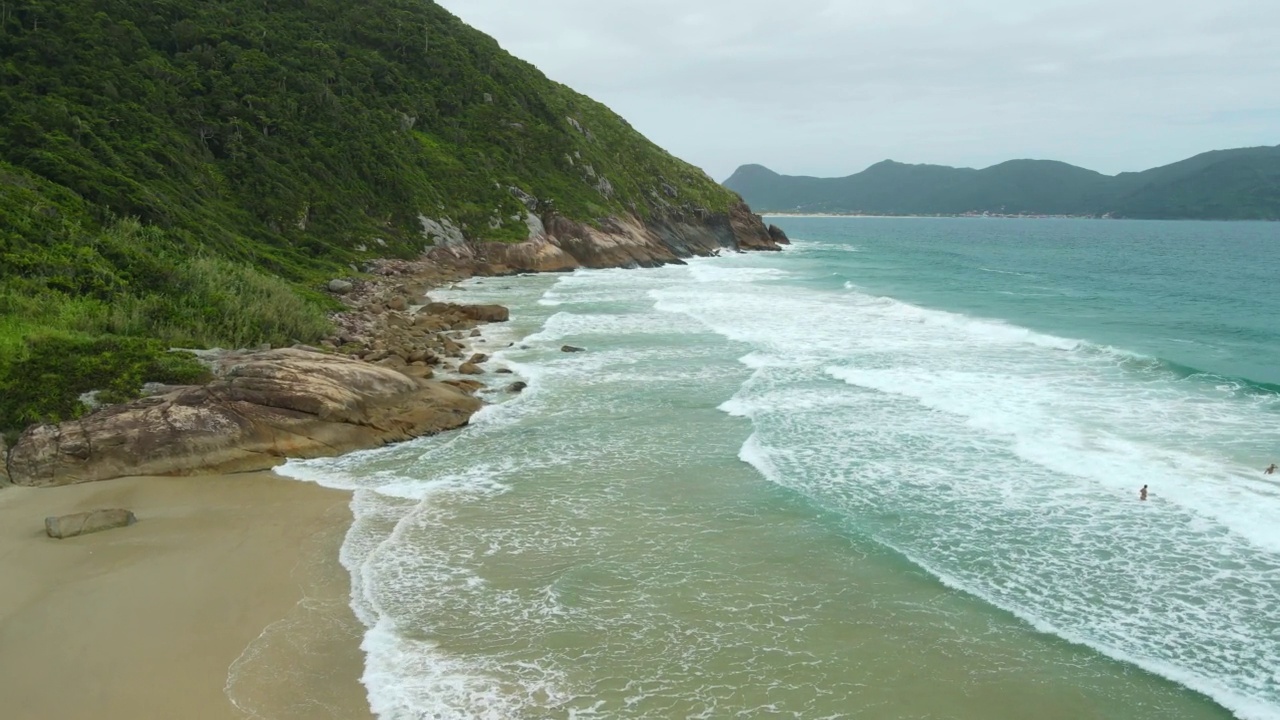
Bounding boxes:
[280,218,1280,720]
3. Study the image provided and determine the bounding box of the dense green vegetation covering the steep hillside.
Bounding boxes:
[0,0,732,429]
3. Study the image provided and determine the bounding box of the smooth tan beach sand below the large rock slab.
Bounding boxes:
[0,474,370,720]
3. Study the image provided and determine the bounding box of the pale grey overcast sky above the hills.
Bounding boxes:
[440,0,1280,179]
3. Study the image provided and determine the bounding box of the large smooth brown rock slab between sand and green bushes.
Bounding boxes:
[9,348,481,486]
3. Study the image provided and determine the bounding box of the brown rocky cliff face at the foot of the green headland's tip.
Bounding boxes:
[429,202,790,275]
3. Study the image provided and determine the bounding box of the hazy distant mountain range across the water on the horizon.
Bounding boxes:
[724,146,1280,220]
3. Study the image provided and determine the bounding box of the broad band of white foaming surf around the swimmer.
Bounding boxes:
[657,267,1280,719]
